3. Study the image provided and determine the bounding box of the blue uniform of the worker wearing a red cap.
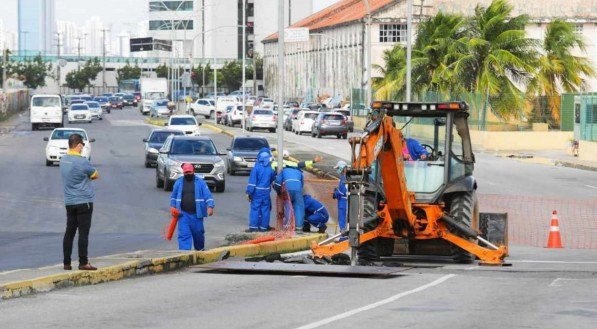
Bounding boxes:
[170,175,215,250]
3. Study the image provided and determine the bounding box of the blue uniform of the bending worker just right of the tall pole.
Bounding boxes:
[274,167,305,228]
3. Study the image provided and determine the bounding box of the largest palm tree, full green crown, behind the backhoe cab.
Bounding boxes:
[443,0,537,128]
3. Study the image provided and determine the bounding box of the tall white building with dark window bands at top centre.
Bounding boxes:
[147,0,313,58]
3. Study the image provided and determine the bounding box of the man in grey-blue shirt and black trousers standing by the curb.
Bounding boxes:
[60,134,99,271]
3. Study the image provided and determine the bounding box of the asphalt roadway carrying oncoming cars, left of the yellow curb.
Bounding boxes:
[0,108,254,271]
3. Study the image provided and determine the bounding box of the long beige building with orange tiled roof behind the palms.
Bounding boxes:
[263,0,597,103]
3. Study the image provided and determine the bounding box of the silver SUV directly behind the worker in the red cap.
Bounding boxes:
[155,136,226,192]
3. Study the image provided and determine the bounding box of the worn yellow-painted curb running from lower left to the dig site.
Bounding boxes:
[0,234,327,300]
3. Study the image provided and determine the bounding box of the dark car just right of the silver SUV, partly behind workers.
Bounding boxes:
[226,136,269,175]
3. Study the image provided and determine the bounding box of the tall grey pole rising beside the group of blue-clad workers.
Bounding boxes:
[277,0,285,172]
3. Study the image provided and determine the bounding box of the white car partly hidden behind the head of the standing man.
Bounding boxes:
[44,128,95,166]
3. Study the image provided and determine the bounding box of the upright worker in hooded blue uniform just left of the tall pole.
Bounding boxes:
[246,148,276,231]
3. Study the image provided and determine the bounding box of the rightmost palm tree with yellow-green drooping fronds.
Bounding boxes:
[527,20,596,122]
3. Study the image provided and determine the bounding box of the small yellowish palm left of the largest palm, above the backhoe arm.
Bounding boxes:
[373,43,406,100]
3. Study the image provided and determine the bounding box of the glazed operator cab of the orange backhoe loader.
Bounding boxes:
[366,102,476,203]
